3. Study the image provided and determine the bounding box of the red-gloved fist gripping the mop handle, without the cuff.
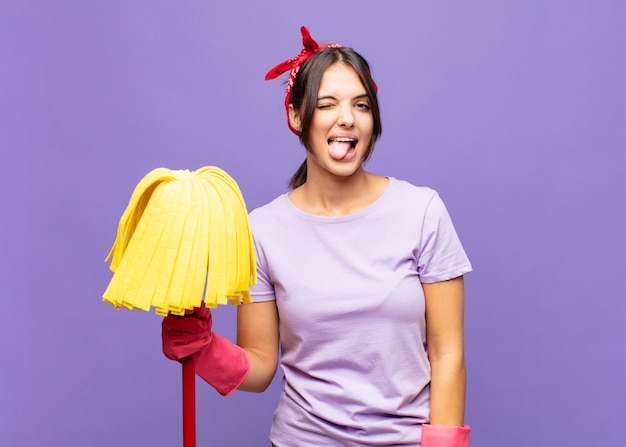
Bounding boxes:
[161,303,213,360]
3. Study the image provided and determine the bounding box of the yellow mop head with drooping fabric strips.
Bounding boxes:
[103,166,256,315]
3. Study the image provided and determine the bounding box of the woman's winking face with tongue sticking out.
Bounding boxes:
[294,63,374,182]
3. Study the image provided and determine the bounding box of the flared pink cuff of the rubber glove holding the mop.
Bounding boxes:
[195,333,250,396]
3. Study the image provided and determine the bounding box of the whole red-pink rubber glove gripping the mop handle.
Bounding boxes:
[161,305,250,396]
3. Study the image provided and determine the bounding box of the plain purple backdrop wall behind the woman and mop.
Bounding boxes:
[0,0,626,447]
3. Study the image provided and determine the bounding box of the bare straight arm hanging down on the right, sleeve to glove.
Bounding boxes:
[423,276,465,426]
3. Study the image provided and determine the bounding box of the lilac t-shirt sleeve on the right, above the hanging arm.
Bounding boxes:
[417,193,472,283]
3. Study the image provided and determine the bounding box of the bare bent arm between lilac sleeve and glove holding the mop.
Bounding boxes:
[237,301,279,392]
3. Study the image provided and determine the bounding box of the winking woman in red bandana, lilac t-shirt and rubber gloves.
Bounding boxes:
[163,27,471,447]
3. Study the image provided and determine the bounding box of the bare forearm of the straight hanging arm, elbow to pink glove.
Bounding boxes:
[430,353,466,426]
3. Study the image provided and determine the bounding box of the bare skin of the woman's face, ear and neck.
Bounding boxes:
[289,64,388,216]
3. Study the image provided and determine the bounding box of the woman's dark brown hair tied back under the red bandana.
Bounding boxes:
[289,47,383,189]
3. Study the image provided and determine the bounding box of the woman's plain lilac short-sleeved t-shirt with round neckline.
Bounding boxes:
[250,178,471,447]
